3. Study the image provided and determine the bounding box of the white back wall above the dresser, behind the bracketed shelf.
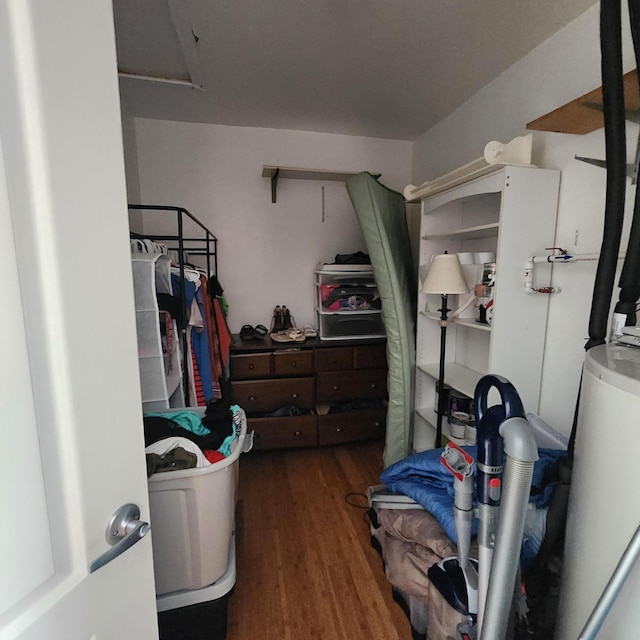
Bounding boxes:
[135,119,412,333]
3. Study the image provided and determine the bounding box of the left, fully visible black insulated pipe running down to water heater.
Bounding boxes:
[585,0,627,350]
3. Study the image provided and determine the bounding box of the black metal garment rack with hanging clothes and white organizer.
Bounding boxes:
[129,204,230,411]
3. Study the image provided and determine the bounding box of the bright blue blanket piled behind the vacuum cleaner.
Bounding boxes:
[380,446,567,544]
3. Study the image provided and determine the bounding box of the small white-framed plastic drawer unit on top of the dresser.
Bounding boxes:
[315,265,385,340]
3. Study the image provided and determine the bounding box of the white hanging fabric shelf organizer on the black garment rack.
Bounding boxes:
[131,254,185,411]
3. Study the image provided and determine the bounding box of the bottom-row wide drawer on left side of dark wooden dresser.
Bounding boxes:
[247,416,318,451]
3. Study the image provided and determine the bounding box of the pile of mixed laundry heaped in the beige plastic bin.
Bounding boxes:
[144,403,244,477]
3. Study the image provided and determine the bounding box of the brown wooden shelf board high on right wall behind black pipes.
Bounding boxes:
[527,69,640,135]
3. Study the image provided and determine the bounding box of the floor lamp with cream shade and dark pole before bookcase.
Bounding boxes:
[420,251,469,449]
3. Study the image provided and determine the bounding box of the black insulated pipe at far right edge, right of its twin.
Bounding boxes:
[615,0,640,325]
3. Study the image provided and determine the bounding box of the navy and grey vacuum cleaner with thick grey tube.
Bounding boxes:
[429,375,538,640]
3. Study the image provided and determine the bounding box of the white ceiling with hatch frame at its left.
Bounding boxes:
[114,0,596,140]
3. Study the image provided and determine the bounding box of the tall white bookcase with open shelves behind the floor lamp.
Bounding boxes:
[413,166,560,451]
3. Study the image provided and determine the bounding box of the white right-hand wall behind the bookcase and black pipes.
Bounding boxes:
[413,5,637,435]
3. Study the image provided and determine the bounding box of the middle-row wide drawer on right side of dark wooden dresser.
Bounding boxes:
[316,369,387,402]
